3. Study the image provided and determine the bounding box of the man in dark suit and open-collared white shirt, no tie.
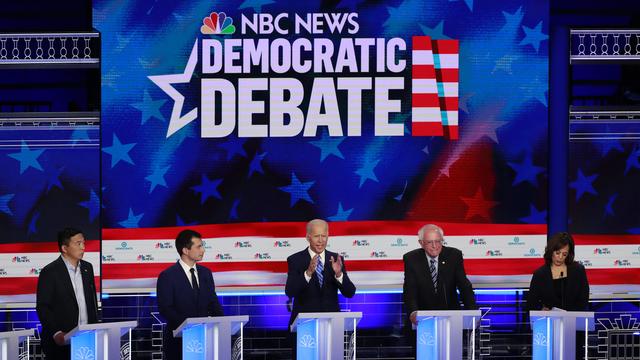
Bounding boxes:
[36,228,98,360]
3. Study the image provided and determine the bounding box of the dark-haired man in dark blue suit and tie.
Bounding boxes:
[157,230,224,360]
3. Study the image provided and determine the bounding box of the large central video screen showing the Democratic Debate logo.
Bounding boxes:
[94,0,549,290]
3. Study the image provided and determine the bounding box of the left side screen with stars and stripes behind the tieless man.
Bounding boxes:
[0,125,100,303]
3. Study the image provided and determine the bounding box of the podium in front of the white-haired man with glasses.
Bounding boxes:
[414,310,481,360]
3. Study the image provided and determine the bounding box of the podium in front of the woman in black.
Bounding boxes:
[529,310,595,360]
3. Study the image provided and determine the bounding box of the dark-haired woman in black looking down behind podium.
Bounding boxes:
[527,232,589,311]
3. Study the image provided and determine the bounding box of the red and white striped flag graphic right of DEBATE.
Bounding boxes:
[411,36,459,140]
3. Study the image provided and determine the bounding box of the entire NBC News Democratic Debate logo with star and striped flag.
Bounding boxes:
[149,12,459,139]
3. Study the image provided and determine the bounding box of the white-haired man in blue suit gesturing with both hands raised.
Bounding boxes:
[285,219,356,356]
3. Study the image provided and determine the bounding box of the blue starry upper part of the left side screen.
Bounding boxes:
[0,126,100,243]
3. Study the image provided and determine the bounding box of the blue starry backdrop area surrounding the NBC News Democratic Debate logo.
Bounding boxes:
[93,0,549,228]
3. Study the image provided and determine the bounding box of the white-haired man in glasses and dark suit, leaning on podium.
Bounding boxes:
[402,224,477,323]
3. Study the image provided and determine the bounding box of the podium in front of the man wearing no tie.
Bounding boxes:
[64,321,138,360]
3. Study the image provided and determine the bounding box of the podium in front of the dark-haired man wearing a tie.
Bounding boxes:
[173,315,249,360]
